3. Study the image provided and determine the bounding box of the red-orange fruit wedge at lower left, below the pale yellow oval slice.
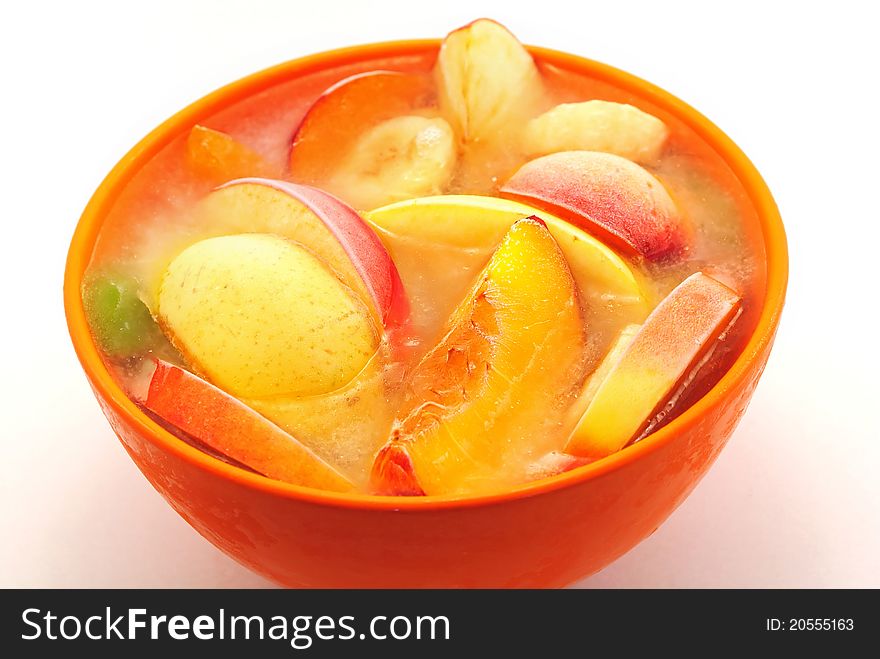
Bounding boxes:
[144,361,354,492]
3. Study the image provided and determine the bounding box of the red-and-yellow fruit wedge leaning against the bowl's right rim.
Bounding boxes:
[565,272,741,458]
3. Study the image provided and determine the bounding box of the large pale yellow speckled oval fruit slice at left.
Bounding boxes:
[158,234,391,484]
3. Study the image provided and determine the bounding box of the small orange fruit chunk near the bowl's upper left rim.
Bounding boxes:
[186,125,276,183]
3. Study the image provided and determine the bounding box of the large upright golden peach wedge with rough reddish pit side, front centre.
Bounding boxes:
[372,218,584,495]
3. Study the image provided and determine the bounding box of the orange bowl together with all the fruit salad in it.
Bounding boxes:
[66,20,785,585]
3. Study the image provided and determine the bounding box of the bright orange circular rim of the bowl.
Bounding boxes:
[64,39,788,512]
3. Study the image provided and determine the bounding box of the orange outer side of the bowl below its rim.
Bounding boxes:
[94,346,769,588]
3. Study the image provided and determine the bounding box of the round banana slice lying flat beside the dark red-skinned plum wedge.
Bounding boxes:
[326,115,456,210]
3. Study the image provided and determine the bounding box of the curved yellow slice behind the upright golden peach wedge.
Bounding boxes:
[365,195,650,338]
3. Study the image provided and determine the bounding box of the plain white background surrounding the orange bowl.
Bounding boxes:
[0,0,880,587]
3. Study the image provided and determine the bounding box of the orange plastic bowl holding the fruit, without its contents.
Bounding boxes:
[64,40,788,587]
